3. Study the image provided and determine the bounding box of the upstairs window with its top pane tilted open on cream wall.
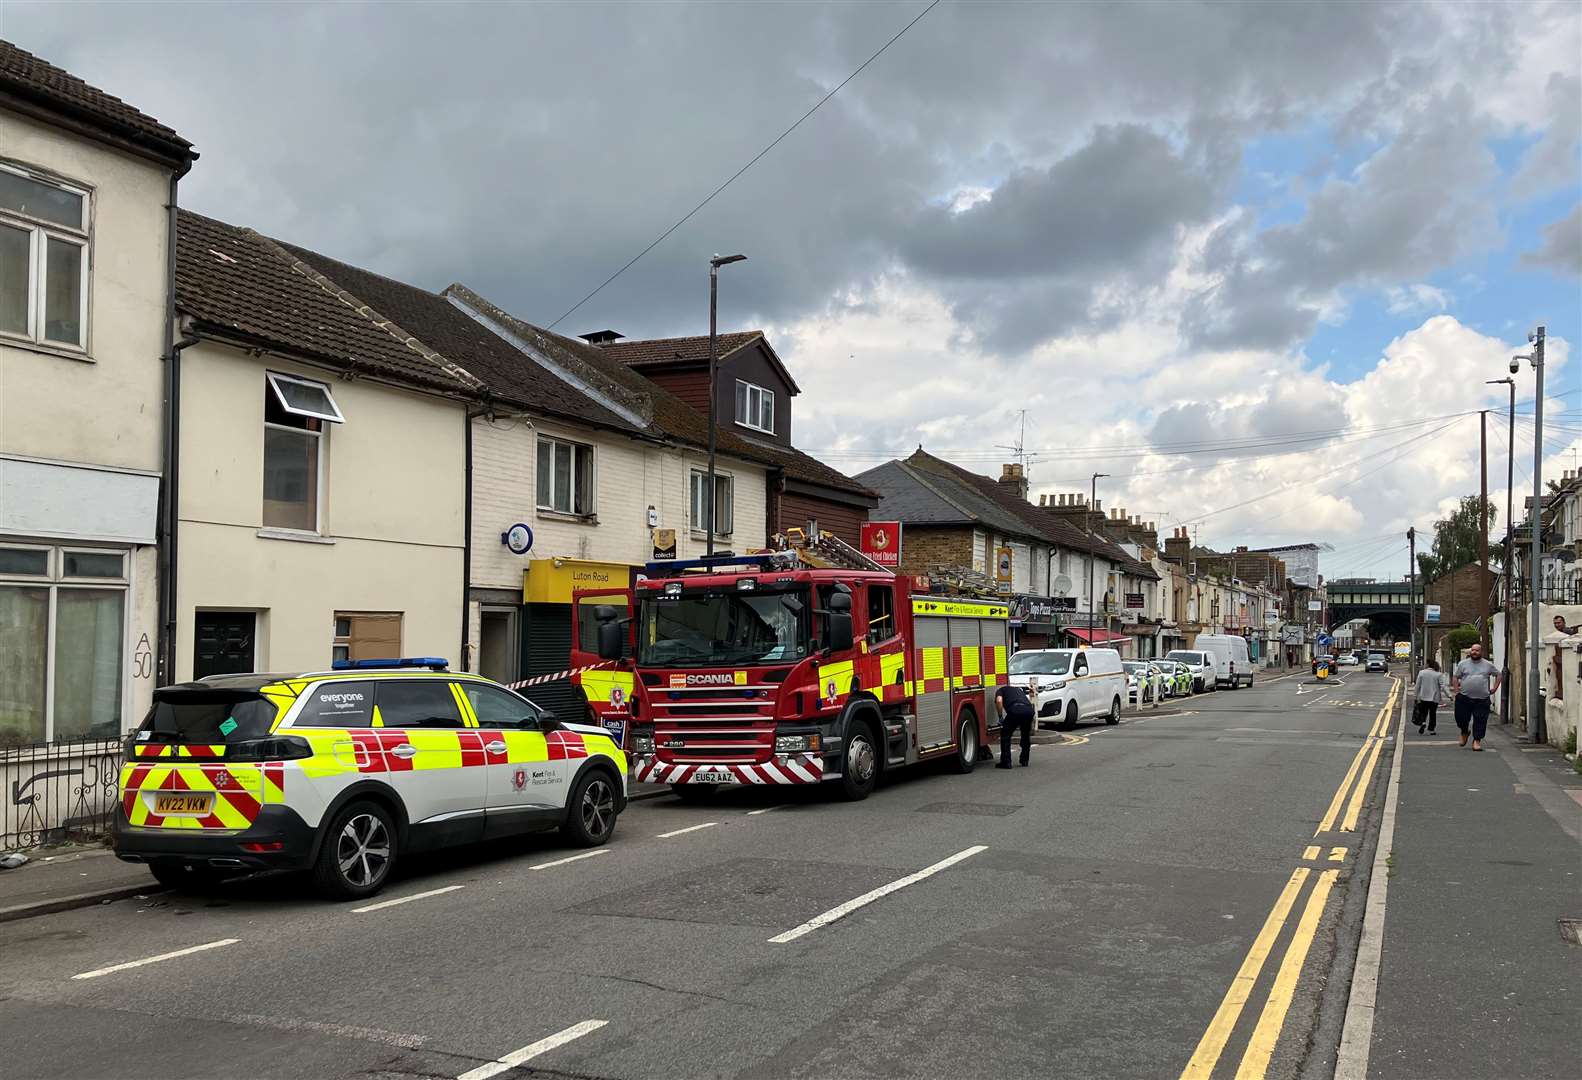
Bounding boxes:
[264,372,343,533]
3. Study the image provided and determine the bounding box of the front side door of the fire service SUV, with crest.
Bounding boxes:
[457,680,569,836]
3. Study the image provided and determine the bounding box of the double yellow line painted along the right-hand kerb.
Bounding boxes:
[1182,682,1400,1080]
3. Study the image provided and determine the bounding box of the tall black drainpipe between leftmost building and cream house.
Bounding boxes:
[153,176,198,686]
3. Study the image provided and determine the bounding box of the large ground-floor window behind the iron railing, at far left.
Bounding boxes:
[0,546,127,746]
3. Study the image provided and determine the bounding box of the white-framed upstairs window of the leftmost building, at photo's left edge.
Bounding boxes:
[0,164,89,349]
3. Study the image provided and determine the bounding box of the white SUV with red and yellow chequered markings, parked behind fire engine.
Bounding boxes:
[114,658,626,900]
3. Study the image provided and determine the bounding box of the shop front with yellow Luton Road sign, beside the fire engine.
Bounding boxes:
[517,558,642,721]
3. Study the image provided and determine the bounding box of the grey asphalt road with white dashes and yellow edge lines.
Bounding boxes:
[0,674,1392,1080]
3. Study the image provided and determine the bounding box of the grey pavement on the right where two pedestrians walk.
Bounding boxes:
[1368,710,1582,1080]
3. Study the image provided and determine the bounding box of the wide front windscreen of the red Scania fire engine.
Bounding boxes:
[638,588,812,667]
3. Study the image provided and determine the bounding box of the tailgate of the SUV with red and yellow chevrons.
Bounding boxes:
[120,685,282,832]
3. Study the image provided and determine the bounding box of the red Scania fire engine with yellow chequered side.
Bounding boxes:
[579,549,1009,799]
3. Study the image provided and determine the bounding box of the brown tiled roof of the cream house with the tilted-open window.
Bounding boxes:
[176,210,476,392]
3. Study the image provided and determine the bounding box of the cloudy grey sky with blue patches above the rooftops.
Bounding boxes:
[15,0,1582,576]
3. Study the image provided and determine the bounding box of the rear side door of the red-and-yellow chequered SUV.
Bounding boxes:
[369,675,487,848]
